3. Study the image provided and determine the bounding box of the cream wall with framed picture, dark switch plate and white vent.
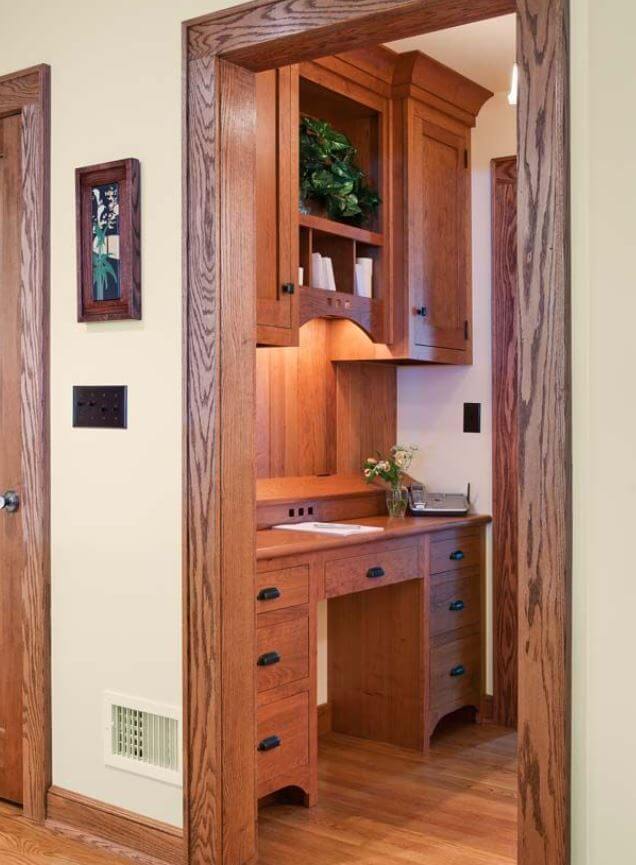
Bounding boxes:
[0,0,236,824]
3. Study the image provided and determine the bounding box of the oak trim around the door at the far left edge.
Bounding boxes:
[0,65,51,822]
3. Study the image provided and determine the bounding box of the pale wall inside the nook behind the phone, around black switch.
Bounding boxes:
[398,93,517,691]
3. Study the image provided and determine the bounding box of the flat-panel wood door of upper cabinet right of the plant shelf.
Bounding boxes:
[408,111,470,351]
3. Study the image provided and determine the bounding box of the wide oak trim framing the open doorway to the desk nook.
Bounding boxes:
[183,0,571,865]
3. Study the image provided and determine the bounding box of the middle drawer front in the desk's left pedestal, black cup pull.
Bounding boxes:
[256,608,309,693]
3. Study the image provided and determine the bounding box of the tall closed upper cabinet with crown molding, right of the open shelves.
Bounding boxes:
[333,49,492,364]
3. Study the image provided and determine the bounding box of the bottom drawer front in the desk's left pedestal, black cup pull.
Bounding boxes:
[256,691,309,786]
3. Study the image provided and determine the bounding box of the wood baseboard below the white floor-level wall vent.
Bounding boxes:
[46,787,183,865]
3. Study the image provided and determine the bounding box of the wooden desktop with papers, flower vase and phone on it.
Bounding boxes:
[256,514,491,559]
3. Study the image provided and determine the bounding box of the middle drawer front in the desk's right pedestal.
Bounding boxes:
[431,568,481,637]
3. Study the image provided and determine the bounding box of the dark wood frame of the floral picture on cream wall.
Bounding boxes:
[75,159,141,322]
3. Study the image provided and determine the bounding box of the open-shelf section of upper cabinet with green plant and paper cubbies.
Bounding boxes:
[299,55,391,343]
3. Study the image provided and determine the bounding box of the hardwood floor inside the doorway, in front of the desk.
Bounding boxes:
[259,725,517,865]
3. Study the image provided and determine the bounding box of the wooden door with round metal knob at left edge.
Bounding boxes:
[0,114,25,802]
